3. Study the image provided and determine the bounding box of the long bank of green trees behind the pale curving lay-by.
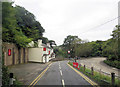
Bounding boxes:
[58,25,120,69]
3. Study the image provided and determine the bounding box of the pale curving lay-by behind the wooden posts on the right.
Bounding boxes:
[78,57,120,76]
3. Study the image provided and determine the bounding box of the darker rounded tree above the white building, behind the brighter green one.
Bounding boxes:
[15,6,45,41]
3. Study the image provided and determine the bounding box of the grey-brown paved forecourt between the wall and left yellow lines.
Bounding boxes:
[9,62,51,85]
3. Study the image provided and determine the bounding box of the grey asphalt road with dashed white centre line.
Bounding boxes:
[30,61,97,87]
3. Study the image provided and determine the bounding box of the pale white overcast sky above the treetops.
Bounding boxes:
[14,0,119,45]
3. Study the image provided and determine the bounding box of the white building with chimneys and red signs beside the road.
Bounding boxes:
[28,40,55,63]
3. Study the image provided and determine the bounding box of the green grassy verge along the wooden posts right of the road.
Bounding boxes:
[68,62,120,87]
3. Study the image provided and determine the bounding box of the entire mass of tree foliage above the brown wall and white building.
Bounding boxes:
[2,2,48,47]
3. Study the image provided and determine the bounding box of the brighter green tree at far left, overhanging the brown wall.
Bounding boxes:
[2,2,32,47]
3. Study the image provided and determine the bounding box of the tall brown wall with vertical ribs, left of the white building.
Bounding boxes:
[2,42,28,66]
